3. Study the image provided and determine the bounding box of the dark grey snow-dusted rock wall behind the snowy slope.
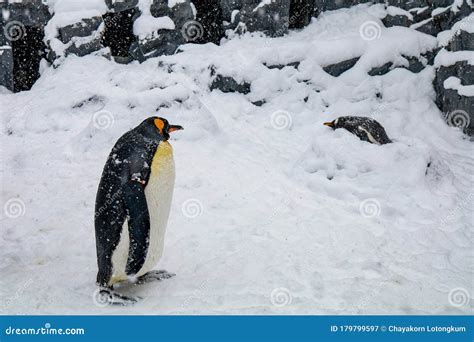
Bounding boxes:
[0,0,474,134]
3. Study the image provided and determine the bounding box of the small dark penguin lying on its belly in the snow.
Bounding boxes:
[324,116,392,145]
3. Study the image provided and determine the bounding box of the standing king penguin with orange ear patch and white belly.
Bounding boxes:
[95,117,183,305]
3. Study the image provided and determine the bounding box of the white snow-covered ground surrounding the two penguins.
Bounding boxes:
[0,6,474,314]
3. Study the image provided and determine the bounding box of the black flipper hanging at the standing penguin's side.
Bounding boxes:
[123,180,150,275]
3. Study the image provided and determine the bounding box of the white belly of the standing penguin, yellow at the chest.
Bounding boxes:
[110,142,175,284]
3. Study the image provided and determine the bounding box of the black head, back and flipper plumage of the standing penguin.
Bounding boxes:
[95,117,182,287]
